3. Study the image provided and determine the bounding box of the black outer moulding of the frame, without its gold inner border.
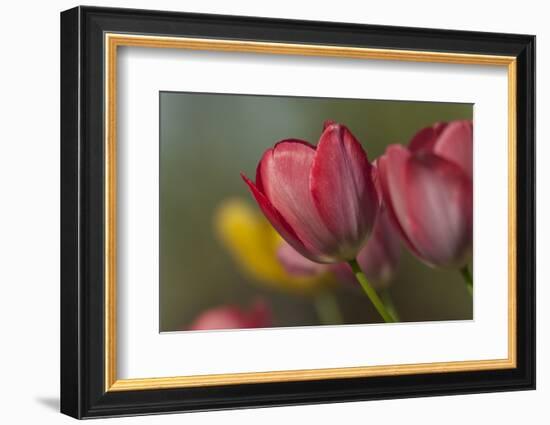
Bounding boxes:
[61,7,535,418]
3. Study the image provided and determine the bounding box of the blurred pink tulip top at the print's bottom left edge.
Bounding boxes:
[187,301,272,331]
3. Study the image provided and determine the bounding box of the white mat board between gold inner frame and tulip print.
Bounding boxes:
[117,47,508,378]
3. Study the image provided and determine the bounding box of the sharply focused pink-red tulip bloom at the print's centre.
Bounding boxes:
[242,122,379,263]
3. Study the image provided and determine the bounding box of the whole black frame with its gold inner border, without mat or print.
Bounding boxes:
[61,7,535,418]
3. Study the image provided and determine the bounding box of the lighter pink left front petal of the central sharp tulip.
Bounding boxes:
[257,140,338,262]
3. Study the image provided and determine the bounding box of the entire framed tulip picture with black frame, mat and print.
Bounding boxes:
[61,7,535,418]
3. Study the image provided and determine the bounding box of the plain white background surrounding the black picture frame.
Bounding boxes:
[0,0,550,425]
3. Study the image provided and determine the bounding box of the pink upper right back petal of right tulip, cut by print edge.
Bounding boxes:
[433,121,473,179]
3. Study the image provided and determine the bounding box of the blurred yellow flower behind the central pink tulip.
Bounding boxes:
[214,198,334,293]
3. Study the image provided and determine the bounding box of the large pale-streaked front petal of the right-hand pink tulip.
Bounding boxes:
[403,155,473,267]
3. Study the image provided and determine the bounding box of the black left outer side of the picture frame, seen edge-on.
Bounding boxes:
[60,7,83,418]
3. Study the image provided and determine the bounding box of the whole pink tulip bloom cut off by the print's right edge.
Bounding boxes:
[378,121,473,268]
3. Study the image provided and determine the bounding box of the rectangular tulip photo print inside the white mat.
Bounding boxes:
[159,92,473,332]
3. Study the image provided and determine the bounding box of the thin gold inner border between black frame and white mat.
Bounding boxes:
[104,33,517,391]
